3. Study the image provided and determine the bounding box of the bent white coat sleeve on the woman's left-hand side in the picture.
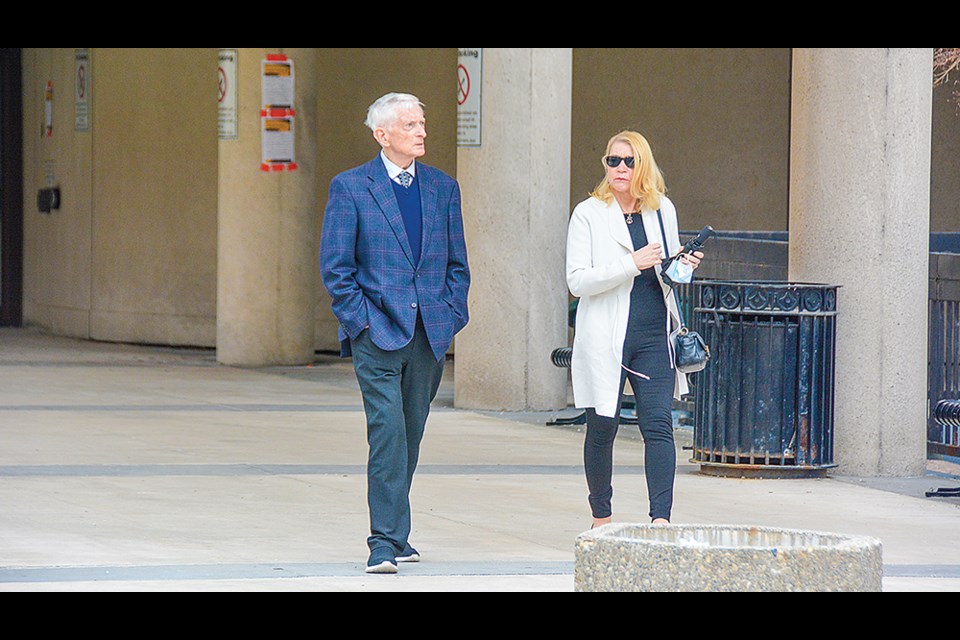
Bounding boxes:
[567,209,640,298]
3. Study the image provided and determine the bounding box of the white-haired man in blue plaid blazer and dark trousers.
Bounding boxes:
[320,93,470,573]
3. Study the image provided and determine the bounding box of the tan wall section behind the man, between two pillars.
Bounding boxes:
[314,48,457,350]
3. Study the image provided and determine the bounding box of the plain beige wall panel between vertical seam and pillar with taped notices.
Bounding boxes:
[91,49,218,346]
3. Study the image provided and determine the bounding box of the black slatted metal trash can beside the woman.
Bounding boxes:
[691,280,838,477]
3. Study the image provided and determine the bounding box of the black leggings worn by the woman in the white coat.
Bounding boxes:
[583,332,677,520]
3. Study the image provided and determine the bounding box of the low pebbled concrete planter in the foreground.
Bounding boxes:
[574,524,883,591]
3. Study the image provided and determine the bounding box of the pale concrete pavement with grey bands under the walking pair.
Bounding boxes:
[0,329,960,592]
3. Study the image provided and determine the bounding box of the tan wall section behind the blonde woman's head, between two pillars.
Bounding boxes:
[570,48,790,230]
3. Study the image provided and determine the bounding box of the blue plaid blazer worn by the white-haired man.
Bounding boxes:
[320,155,470,361]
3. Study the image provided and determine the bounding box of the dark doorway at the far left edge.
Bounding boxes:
[0,47,23,327]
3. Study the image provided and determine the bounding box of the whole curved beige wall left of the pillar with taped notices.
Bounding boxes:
[23,49,217,345]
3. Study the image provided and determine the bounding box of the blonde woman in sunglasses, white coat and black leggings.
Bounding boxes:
[567,131,703,526]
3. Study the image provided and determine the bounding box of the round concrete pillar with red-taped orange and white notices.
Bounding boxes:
[217,49,319,366]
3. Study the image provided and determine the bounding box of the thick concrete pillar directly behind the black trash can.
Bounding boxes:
[789,49,933,476]
